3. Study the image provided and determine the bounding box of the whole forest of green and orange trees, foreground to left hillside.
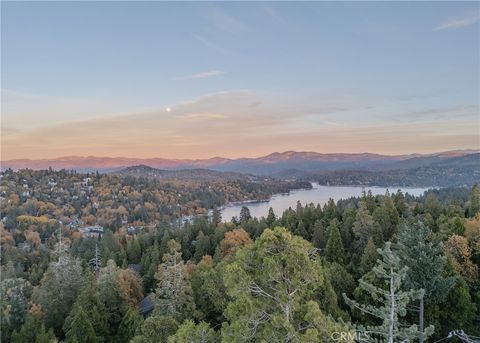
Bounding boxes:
[0,170,480,343]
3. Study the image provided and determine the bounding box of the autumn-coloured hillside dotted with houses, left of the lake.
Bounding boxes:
[0,167,311,234]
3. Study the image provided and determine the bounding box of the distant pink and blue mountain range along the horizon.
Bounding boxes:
[1,150,480,177]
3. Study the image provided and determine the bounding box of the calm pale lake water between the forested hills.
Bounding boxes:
[222,183,428,220]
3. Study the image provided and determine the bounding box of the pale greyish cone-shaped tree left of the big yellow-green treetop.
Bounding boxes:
[154,240,195,322]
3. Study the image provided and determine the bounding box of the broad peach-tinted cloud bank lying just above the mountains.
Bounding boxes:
[1,90,478,160]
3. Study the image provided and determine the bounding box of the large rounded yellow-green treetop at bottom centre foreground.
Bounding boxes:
[222,227,348,342]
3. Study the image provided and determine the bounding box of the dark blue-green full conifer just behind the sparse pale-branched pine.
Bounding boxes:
[397,223,456,342]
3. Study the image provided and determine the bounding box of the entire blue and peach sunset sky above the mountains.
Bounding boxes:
[1,1,480,160]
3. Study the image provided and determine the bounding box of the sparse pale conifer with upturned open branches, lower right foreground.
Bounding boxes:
[344,242,433,343]
